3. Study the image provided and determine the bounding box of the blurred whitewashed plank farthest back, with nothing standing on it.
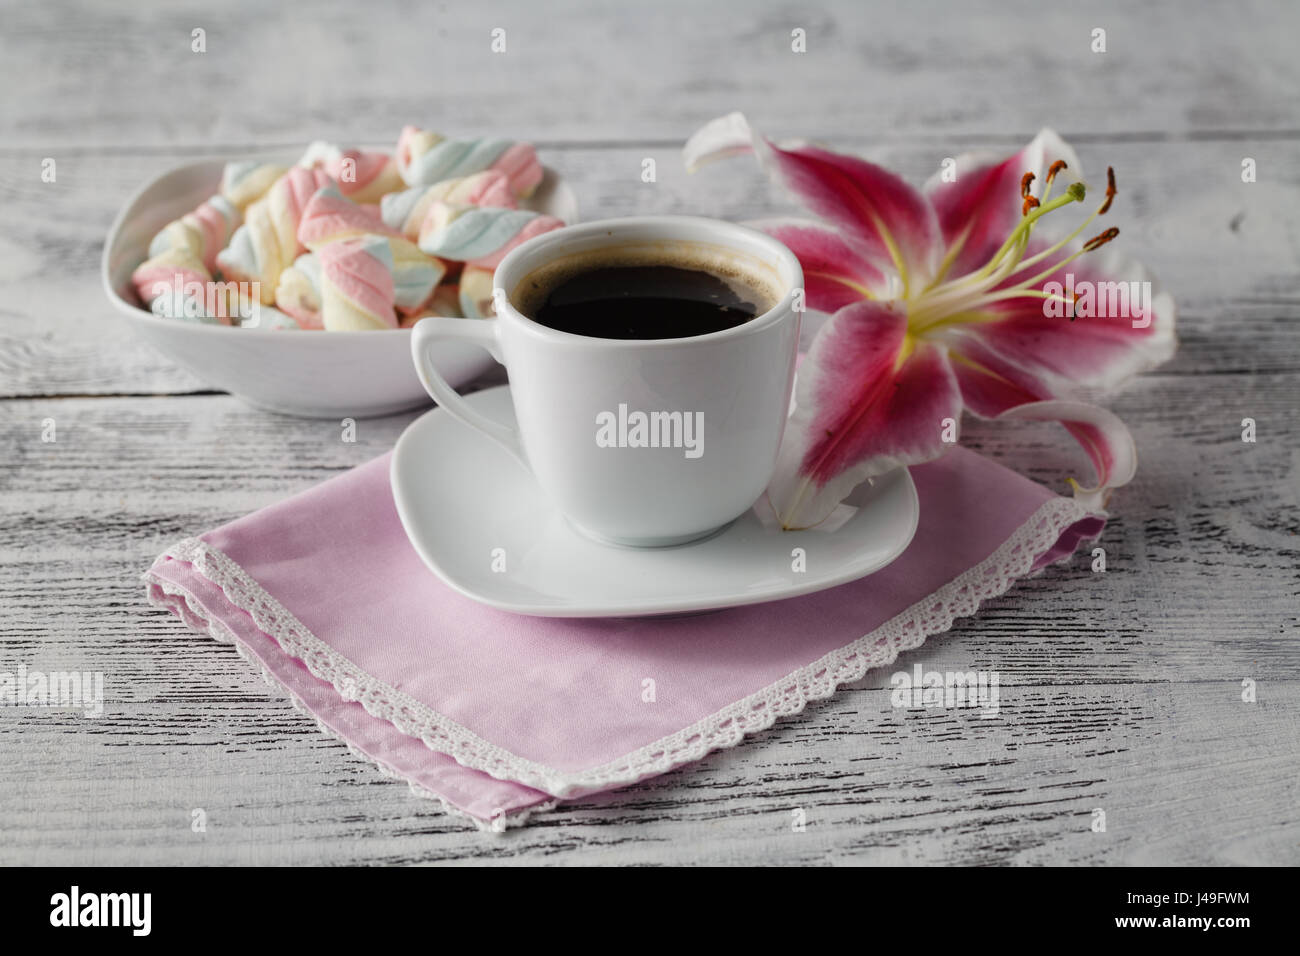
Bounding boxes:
[0,0,1300,148]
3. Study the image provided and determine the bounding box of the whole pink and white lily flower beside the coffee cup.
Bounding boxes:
[684,113,1177,528]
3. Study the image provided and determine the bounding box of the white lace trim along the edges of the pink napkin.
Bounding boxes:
[144,498,1099,830]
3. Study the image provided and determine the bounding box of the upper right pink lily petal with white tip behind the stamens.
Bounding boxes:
[924,129,1083,278]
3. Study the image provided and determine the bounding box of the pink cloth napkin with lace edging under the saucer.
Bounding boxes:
[144,447,1105,830]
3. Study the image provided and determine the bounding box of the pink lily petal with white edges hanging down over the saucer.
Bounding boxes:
[768,302,962,528]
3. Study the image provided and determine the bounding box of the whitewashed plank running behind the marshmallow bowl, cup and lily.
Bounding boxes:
[0,130,1300,397]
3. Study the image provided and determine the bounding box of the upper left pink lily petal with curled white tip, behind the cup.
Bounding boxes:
[683,113,943,286]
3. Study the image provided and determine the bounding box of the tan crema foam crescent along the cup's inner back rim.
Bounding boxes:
[510,239,785,321]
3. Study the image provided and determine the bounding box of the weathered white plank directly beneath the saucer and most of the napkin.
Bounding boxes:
[0,373,1300,686]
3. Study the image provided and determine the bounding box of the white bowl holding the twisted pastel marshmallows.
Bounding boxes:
[103,157,577,419]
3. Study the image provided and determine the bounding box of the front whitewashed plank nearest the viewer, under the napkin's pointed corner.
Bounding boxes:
[0,686,1300,866]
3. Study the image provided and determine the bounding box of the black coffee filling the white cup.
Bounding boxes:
[524,263,775,338]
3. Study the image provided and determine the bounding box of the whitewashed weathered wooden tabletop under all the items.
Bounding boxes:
[0,0,1300,864]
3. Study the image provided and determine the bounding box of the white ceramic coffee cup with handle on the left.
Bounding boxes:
[411,216,803,548]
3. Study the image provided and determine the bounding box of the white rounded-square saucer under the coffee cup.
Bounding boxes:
[390,385,920,618]
